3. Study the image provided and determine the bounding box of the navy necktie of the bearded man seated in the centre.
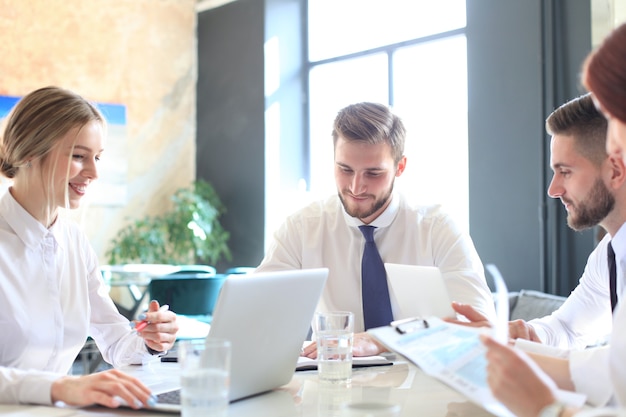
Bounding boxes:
[359,226,393,330]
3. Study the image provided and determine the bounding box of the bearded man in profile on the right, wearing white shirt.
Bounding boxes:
[446,94,626,405]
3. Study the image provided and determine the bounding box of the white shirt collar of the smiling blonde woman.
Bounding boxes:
[0,190,56,247]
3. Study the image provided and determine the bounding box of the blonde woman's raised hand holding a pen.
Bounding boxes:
[130,300,178,352]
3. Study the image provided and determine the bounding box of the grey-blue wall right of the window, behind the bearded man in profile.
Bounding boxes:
[467,0,593,295]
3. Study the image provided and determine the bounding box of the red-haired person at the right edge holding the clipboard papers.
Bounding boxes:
[476,24,626,417]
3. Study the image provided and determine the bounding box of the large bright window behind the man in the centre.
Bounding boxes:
[265,0,469,247]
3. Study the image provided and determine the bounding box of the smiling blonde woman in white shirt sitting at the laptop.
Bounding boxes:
[0,87,178,408]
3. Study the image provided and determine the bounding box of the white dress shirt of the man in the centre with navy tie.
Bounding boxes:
[257,193,495,332]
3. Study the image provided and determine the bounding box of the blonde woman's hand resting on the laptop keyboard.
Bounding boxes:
[50,369,155,409]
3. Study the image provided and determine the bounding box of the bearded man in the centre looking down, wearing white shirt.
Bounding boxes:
[252,103,495,355]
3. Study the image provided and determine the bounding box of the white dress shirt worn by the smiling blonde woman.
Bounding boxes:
[0,192,148,404]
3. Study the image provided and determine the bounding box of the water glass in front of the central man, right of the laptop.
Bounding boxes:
[313,311,354,383]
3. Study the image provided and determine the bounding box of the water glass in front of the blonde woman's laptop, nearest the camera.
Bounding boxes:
[178,339,231,417]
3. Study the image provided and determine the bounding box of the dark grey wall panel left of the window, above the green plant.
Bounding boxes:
[197,0,265,270]
